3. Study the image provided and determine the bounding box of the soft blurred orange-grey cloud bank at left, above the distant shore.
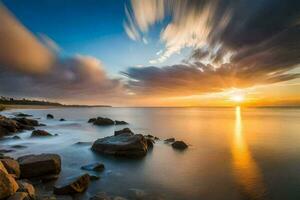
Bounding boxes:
[0,5,123,102]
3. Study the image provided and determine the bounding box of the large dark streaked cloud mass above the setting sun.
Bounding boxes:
[123,0,300,96]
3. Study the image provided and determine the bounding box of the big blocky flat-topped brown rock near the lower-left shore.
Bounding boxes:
[18,154,61,178]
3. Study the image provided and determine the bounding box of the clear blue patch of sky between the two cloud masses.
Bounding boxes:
[3,0,189,76]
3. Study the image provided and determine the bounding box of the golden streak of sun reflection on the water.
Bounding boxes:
[232,107,266,200]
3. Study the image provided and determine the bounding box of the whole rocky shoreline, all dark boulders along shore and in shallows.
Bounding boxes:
[0,113,188,200]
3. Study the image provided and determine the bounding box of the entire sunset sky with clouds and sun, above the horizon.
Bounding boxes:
[0,0,300,106]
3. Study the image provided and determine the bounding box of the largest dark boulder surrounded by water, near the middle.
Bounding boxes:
[92,134,148,157]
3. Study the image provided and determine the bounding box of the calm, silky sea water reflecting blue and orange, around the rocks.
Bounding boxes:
[0,108,300,200]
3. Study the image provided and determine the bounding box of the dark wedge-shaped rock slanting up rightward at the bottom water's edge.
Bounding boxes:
[53,174,90,195]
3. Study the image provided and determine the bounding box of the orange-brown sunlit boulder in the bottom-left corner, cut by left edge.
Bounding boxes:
[0,170,19,199]
